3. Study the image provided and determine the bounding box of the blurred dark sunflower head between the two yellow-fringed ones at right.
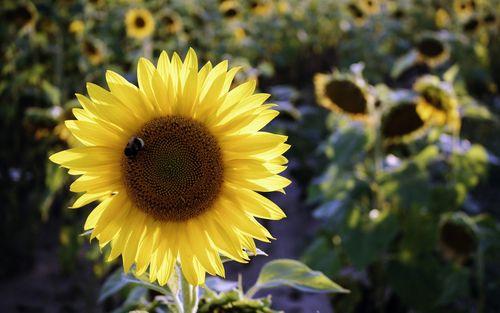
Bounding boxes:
[381,96,426,144]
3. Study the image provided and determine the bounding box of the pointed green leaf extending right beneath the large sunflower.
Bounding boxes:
[249,259,349,294]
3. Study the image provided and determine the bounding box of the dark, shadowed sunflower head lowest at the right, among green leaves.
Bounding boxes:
[439,213,477,263]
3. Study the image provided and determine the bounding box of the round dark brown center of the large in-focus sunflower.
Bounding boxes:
[122,116,223,221]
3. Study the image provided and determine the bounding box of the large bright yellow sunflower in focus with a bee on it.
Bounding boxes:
[50,49,290,285]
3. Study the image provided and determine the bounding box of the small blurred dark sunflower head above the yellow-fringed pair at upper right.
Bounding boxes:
[416,34,450,67]
